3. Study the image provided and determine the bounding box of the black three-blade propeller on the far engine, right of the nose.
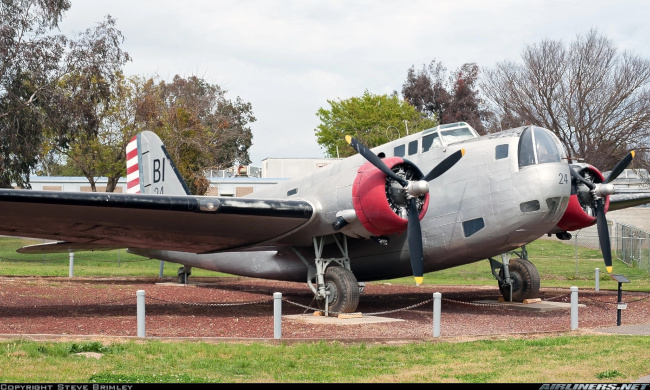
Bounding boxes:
[569,151,634,274]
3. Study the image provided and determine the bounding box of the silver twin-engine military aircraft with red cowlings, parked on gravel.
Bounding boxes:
[0,122,650,313]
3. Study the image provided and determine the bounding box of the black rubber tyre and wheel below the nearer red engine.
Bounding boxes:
[321,266,359,313]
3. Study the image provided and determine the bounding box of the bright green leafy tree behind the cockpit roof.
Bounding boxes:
[315,90,436,157]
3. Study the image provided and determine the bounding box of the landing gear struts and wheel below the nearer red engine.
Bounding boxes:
[293,234,365,315]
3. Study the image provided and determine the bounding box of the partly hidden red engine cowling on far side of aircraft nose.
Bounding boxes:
[557,164,609,232]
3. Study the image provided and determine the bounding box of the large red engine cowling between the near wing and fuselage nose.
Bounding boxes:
[352,157,429,236]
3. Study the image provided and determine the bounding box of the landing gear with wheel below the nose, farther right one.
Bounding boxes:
[489,246,540,302]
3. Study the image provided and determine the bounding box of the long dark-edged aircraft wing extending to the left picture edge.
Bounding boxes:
[0,189,314,253]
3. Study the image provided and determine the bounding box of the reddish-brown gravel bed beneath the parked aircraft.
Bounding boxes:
[0,277,650,341]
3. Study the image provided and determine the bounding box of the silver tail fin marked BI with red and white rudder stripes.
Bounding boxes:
[126,131,191,195]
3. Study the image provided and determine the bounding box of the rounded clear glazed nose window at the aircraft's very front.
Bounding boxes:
[519,126,562,168]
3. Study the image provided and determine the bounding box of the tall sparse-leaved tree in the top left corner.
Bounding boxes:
[0,0,130,188]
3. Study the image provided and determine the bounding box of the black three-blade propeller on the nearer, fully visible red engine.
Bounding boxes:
[345,135,465,284]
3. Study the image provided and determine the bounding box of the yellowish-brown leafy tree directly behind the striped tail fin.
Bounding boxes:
[137,76,256,194]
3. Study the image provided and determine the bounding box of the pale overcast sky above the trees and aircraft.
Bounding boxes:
[61,0,650,166]
